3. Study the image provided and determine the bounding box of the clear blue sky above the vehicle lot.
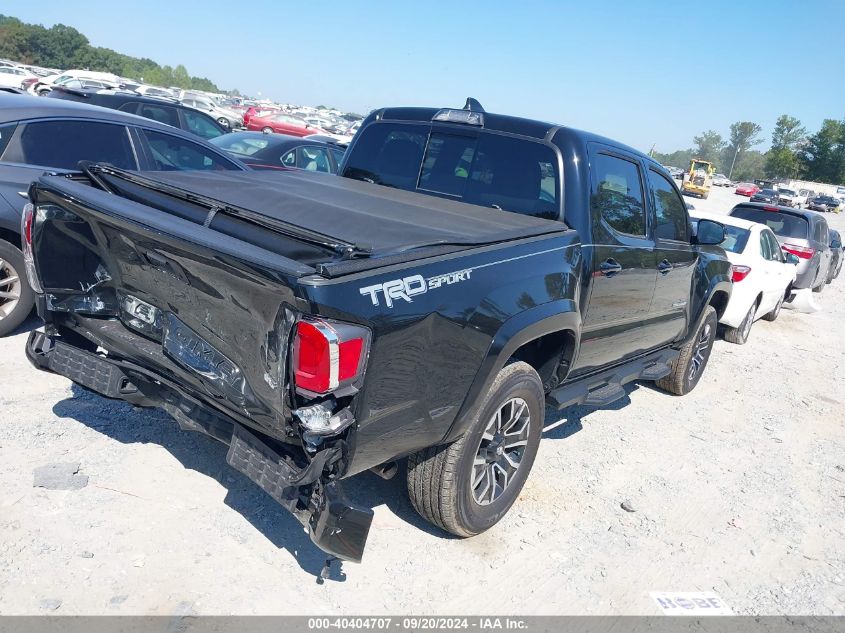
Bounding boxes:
[6,0,845,151]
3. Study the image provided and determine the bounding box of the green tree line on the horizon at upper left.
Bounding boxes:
[0,15,234,92]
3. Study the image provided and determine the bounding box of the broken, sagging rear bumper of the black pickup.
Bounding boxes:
[26,331,373,562]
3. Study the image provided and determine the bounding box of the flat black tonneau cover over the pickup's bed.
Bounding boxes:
[107,171,566,255]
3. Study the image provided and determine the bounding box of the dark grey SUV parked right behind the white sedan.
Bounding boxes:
[730,202,833,292]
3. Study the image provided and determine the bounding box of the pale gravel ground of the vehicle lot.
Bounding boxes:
[0,185,845,615]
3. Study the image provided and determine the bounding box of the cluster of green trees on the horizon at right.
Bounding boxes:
[652,114,845,185]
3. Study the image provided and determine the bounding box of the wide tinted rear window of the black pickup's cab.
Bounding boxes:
[343,123,560,220]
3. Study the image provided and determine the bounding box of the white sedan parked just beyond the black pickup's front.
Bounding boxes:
[692,212,798,345]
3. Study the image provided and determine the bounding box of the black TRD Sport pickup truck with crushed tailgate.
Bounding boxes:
[23,102,731,561]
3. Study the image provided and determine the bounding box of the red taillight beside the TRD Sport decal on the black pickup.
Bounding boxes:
[293,319,370,394]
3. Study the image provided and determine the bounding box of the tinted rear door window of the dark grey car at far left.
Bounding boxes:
[4,120,138,170]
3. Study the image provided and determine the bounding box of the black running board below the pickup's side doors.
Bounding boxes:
[546,349,680,410]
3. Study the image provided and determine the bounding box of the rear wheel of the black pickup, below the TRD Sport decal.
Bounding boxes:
[408,362,545,536]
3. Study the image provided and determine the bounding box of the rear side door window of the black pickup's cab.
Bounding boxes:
[590,154,646,237]
